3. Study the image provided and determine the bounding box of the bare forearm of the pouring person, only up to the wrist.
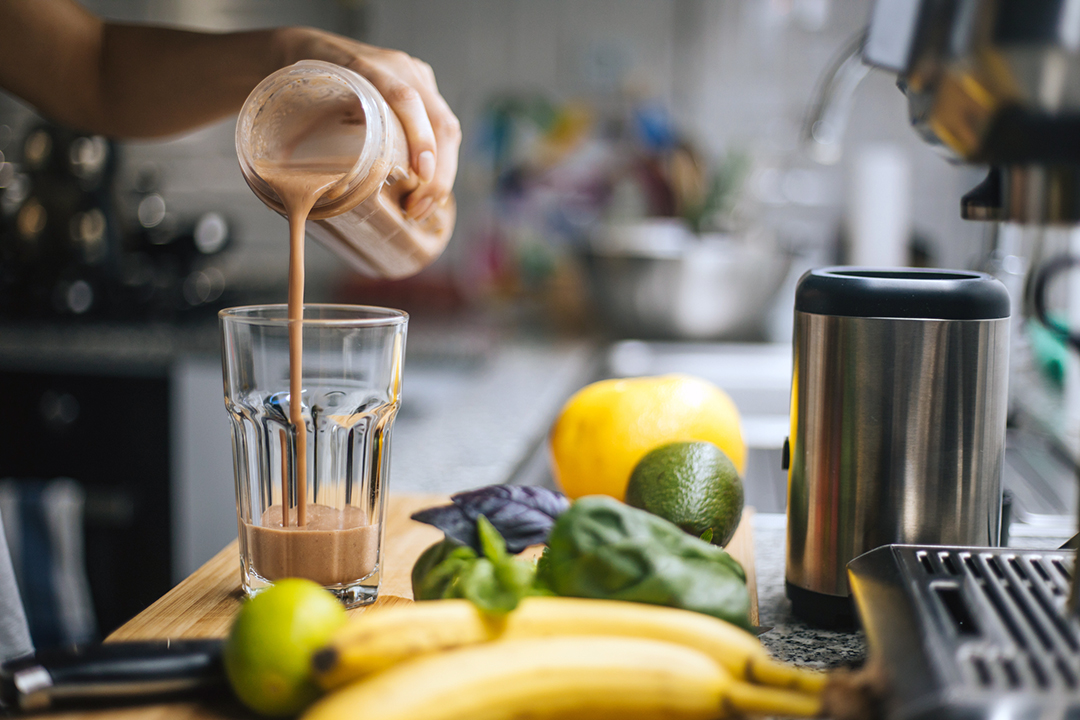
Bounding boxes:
[0,0,283,137]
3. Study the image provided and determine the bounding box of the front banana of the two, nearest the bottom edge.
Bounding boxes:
[303,636,821,720]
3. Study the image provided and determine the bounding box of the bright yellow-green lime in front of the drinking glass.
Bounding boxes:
[224,579,346,717]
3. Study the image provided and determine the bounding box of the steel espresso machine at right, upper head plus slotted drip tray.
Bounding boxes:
[805,0,1080,718]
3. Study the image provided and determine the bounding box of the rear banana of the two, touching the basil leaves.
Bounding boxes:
[313,597,826,694]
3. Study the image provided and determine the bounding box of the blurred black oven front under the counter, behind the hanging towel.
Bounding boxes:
[0,369,175,649]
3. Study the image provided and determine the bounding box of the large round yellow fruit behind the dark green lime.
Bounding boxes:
[551,375,746,500]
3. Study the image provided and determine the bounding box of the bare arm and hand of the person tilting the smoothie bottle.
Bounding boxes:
[0,0,460,216]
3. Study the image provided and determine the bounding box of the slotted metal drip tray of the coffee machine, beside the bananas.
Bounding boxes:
[849,545,1080,718]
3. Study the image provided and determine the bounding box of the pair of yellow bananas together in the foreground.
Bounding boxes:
[309,597,826,720]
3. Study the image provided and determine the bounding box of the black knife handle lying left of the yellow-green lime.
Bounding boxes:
[0,640,225,711]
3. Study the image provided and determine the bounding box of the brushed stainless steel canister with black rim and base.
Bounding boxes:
[785,267,1009,626]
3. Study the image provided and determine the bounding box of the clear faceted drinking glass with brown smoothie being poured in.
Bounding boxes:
[219,304,408,607]
